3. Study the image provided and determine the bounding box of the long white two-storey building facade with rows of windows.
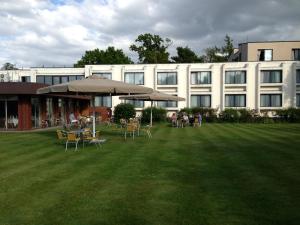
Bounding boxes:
[0,61,300,112]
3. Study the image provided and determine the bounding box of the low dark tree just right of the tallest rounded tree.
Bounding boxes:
[171,46,203,63]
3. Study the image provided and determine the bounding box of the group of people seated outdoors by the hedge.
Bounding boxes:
[171,112,202,127]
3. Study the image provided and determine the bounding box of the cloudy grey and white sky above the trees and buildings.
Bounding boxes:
[0,0,300,68]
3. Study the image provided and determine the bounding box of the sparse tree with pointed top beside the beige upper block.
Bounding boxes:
[204,34,234,62]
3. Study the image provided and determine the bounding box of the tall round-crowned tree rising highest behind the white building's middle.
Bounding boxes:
[130,33,171,63]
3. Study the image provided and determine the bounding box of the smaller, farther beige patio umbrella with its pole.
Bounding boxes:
[120,91,185,127]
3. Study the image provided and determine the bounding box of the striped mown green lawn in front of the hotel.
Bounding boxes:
[0,124,300,225]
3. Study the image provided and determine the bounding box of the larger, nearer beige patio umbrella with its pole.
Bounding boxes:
[37,76,153,137]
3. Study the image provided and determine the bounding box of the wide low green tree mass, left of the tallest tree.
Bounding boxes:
[74,47,133,67]
